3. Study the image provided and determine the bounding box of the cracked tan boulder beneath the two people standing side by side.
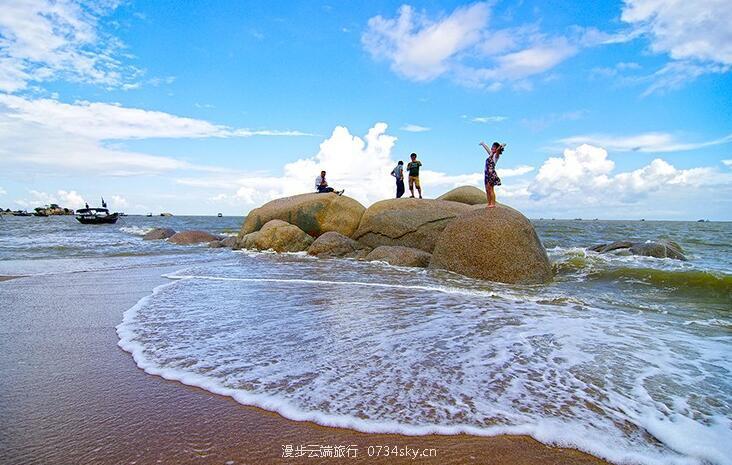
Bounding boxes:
[351,199,472,252]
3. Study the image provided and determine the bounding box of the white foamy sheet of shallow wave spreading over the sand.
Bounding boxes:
[117,256,732,464]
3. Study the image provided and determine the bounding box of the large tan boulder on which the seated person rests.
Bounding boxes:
[239,193,365,238]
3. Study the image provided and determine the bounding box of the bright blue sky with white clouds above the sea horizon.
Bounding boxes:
[0,0,732,220]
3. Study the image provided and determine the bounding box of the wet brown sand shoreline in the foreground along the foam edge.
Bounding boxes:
[0,267,605,465]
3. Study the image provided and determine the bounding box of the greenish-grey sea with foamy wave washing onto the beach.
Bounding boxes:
[0,216,732,465]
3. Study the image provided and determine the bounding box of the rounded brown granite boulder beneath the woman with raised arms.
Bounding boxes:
[430,204,552,284]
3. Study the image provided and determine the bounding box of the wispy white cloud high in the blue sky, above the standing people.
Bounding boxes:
[361,2,577,90]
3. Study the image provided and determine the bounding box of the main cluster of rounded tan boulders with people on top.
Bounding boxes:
[234,187,552,284]
